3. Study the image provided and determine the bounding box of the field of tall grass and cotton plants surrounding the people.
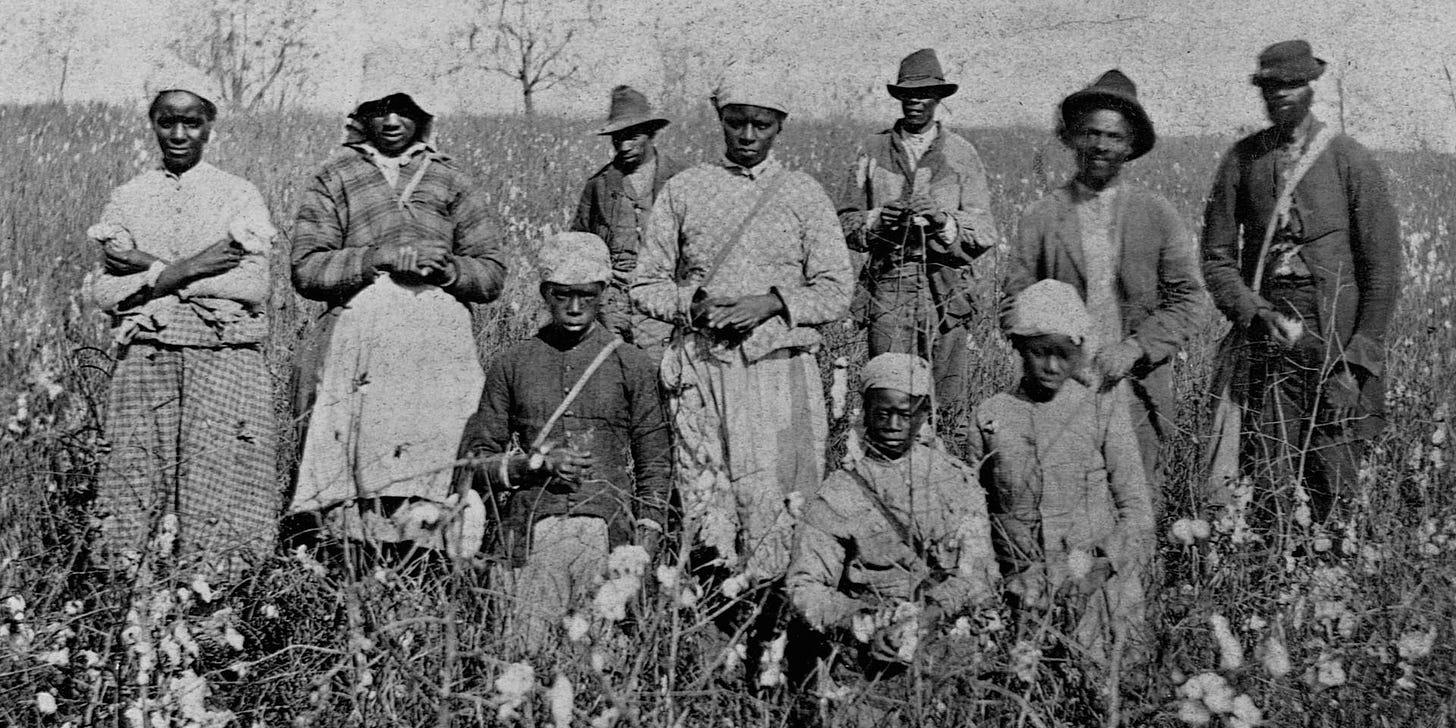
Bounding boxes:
[0,105,1456,727]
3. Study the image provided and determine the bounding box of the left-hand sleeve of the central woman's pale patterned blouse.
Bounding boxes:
[630,178,695,323]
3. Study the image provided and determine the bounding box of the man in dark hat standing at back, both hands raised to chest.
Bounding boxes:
[839,48,997,419]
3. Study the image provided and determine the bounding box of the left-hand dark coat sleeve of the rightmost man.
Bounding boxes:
[1201,147,1268,328]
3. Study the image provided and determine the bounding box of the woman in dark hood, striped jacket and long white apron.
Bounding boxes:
[290,78,505,558]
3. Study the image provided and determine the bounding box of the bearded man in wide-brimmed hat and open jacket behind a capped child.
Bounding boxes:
[1002,70,1204,514]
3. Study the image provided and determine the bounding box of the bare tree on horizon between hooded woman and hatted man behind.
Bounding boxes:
[448,0,597,116]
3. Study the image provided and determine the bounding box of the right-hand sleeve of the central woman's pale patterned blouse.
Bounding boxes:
[773,179,855,326]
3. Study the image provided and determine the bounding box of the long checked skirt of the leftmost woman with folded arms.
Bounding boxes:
[96,342,282,562]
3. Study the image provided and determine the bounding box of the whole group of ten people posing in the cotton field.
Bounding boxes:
[87,41,1401,716]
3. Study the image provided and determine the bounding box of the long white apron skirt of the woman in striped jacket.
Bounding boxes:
[288,275,485,549]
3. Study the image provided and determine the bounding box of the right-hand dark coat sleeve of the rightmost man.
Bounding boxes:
[1344,143,1405,376]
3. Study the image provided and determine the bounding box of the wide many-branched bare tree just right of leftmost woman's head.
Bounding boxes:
[170,0,319,109]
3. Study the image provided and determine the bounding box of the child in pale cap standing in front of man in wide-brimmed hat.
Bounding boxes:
[968,280,1153,664]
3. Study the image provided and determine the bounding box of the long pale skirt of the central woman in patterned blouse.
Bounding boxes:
[662,335,828,579]
